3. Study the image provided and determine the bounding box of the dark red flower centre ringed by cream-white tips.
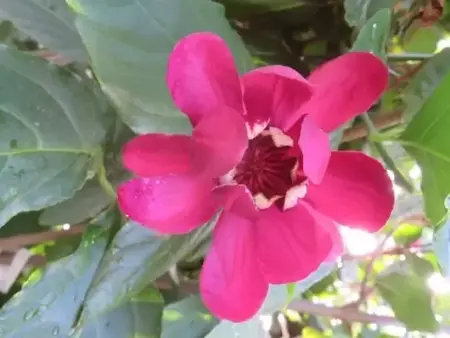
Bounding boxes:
[233,127,306,210]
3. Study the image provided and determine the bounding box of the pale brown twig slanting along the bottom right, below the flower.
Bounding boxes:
[288,299,450,332]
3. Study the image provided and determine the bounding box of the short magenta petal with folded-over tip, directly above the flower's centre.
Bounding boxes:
[242,66,312,134]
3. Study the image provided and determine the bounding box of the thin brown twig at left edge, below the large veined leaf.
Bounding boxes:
[0,223,86,251]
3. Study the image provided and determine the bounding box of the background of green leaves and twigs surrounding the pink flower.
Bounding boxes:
[0,0,450,338]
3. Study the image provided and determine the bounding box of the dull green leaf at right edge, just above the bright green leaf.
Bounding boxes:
[402,48,450,121]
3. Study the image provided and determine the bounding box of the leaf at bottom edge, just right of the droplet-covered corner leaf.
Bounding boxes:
[75,287,164,338]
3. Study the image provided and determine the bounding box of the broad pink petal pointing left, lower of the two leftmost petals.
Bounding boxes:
[118,175,217,234]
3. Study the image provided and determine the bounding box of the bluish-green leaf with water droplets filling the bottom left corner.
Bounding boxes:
[0,214,115,338]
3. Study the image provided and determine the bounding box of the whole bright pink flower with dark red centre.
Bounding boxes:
[118,33,394,322]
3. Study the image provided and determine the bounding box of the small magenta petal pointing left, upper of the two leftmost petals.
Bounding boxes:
[122,134,194,176]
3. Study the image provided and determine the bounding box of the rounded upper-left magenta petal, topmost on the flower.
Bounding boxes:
[167,33,243,125]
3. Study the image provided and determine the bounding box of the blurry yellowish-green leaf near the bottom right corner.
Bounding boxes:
[375,262,438,332]
